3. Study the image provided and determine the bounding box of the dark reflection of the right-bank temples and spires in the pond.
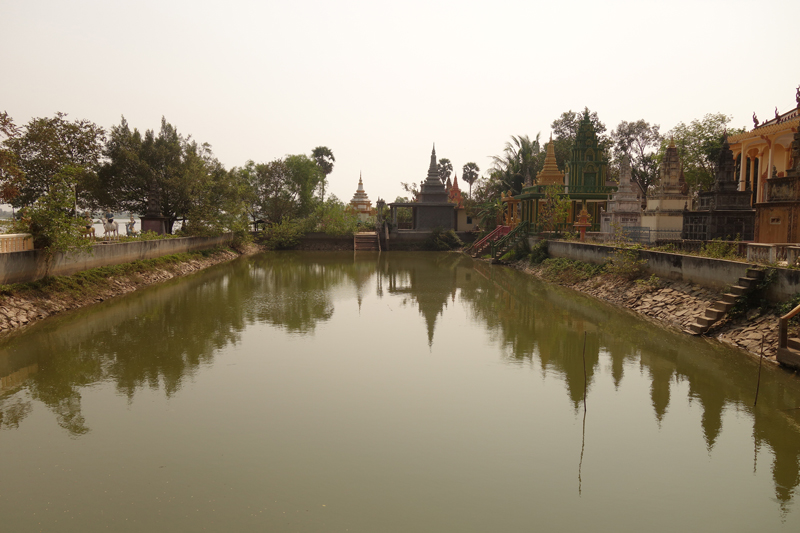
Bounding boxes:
[459,263,800,512]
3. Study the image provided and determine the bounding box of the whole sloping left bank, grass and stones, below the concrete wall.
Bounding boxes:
[0,245,259,337]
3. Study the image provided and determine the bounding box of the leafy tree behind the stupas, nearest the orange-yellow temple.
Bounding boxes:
[662,113,744,192]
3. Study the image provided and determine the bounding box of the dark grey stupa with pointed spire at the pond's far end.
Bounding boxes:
[389,146,456,231]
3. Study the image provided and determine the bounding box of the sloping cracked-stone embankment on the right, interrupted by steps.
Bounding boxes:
[514,262,779,362]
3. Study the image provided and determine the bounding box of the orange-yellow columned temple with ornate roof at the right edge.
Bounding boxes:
[729,87,800,243]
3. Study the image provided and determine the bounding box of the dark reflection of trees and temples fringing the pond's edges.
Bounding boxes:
[0,253,800,510]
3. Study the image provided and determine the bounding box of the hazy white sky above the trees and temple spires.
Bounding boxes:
[0,0,800,202]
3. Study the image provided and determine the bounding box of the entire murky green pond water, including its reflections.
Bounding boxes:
[0,253,800,533]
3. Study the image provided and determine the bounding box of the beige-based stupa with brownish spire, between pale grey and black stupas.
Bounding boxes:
[642,139,690,239]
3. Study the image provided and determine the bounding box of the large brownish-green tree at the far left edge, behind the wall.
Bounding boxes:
[4,113,105,207]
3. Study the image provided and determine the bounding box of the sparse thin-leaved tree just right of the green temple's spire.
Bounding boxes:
[611,119,662,192]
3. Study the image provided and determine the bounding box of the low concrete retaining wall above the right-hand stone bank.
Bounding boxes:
[548,241,800,302]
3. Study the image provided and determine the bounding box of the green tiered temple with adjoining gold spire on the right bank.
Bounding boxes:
[516,110,615,231]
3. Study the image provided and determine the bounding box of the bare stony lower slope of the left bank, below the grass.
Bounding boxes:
[0,243,250,337]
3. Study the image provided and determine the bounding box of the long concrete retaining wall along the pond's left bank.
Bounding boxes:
[0,234,233,284]
